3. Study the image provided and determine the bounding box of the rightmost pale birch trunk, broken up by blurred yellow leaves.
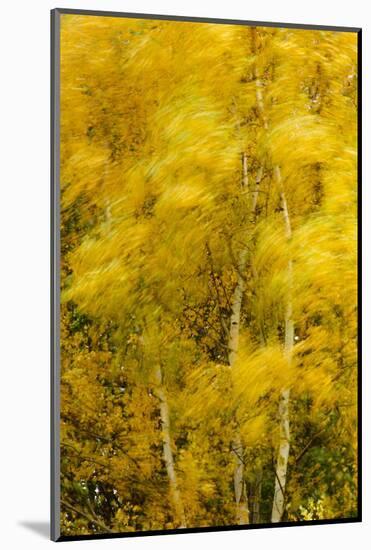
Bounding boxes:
[271,166,294,523]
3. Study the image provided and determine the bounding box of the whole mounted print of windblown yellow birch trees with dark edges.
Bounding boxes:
[52,9,361,540]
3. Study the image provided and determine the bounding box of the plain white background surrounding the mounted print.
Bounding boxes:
[0,0,371,550]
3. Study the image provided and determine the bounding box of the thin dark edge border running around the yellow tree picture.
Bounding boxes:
[50,8,363,542]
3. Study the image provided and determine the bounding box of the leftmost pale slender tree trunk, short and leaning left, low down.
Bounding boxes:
[155,364,187,528]
